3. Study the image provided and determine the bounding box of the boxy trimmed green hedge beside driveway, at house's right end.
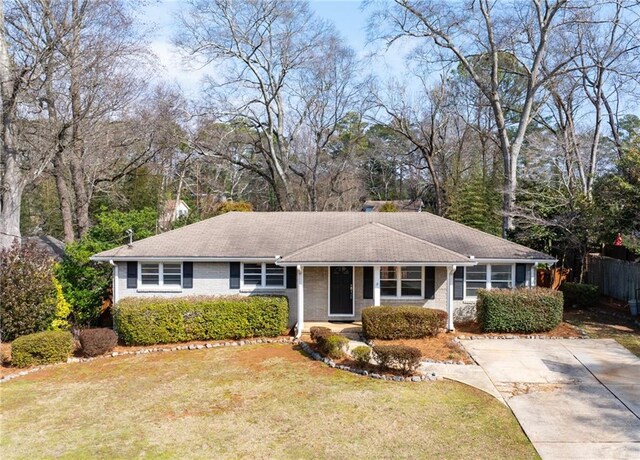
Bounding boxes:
[477,288,563,333]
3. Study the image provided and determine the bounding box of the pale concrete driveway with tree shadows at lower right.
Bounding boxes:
[463,339,640,459]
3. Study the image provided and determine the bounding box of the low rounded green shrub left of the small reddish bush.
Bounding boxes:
[11,331,75,367]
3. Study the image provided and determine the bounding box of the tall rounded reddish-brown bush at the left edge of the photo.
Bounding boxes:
[0,242,56,342]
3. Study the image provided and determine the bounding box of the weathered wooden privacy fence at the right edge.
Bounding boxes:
[586,254,640,301]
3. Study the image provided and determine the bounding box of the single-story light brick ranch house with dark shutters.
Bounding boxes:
[92,212,555,334]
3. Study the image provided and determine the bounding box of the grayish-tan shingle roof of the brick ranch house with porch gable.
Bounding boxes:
[94,212,553,262]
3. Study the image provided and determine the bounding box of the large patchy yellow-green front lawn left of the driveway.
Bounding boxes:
[0,345,537,459]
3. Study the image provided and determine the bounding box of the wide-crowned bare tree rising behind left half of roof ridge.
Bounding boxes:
[177,0,362,209]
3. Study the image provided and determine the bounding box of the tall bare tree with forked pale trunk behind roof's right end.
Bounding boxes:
[372,0,577,235]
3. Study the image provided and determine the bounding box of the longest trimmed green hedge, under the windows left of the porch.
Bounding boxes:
[113,296,289,345]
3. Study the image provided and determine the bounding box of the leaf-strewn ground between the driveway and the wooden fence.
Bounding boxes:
[565,310,640,358]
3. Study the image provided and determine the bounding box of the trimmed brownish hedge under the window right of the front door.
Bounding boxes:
[362,306,447,340]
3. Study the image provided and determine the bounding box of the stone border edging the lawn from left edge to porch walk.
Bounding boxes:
[0,337,297,383]
